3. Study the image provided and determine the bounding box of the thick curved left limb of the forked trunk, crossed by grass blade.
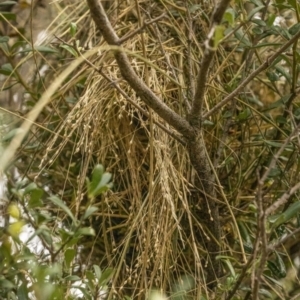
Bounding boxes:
[87,0,194,138]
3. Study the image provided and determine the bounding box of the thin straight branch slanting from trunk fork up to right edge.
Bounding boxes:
[203,31,300,119]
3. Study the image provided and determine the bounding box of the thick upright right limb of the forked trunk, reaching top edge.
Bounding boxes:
[189,0,230,125]
